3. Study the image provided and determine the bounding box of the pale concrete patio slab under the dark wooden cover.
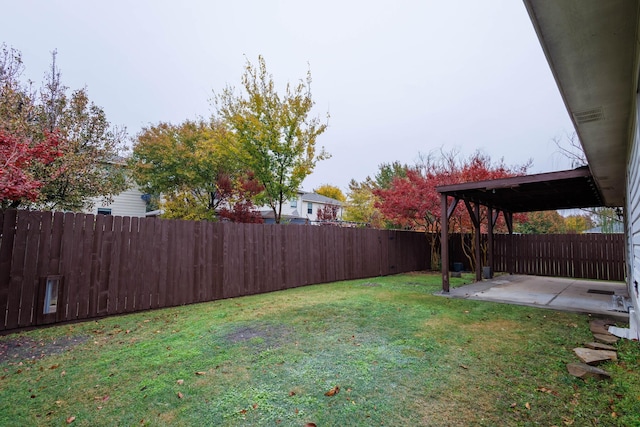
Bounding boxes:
[439,275,629,320]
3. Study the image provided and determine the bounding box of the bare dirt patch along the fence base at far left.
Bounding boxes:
[0,335,89,363]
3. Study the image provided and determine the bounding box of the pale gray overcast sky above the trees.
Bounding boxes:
[0,0,573,191]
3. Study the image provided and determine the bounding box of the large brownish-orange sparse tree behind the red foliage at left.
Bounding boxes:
[0,45,126,211]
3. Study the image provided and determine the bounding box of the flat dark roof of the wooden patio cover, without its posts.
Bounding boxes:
[436,166,603,212]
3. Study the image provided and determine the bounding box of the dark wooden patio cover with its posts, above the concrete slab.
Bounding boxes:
[436,166,604,292]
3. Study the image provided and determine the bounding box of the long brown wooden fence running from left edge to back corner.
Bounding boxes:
[0,210,430,329]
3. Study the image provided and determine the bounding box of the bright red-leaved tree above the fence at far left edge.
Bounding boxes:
[0,130,62,209]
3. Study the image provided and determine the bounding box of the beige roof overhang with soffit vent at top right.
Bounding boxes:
[524,0,640,206]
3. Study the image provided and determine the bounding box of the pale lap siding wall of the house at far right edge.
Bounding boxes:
[625,97,640,325]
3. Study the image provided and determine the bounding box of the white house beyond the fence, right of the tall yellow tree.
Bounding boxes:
[259,190,344,224]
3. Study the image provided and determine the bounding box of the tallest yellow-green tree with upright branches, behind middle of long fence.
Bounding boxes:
[214,56,329,223]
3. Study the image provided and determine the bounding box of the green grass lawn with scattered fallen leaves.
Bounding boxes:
[0,274,640,427]
